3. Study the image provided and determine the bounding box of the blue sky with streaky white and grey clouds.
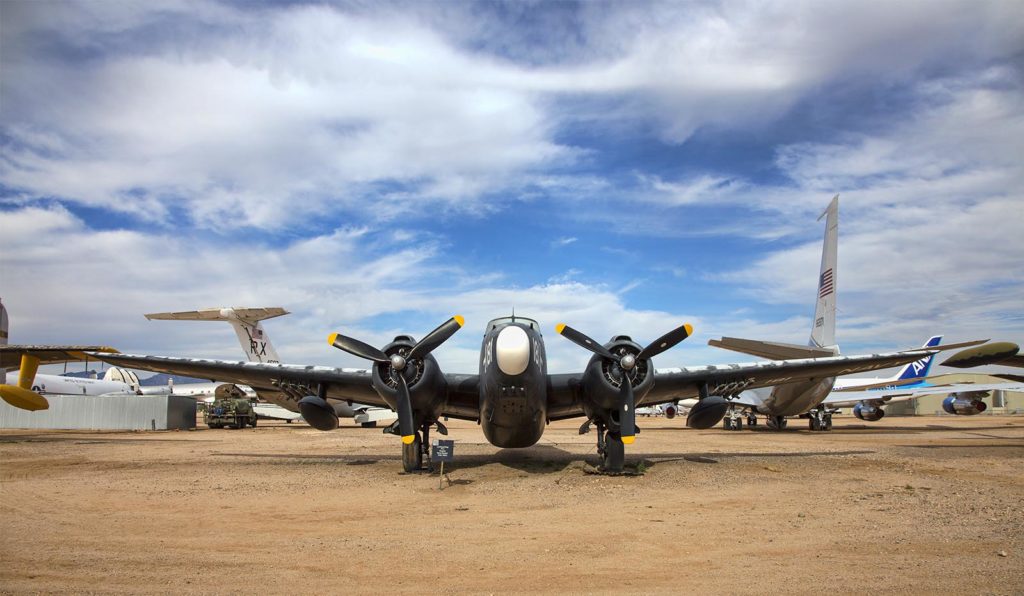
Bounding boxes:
[0,0,1024,378]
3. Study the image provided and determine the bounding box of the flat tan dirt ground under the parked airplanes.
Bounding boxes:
[0,417,1024,594]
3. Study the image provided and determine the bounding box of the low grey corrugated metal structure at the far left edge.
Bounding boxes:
[0,394,196,430]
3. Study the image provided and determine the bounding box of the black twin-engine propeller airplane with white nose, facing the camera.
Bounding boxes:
[91,315,934,473]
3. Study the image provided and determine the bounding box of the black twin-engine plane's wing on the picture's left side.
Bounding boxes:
[82,353,480,420]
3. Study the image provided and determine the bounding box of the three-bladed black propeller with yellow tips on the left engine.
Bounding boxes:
[327,314,465,444]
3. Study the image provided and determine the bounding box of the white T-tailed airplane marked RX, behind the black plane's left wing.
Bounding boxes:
[143,306,397,427]
